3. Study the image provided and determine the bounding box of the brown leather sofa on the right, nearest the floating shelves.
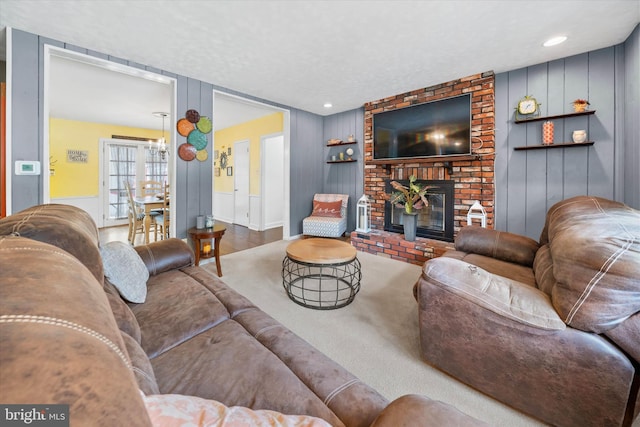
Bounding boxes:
[415,196,640,427]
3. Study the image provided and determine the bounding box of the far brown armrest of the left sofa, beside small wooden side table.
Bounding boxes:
[134,238,195,276]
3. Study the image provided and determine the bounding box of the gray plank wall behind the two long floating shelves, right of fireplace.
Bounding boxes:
[495,39,638,240]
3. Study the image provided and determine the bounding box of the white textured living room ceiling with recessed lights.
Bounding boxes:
[0,0,640,128]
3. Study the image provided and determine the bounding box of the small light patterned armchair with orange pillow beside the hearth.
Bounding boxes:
[302,194,349,237]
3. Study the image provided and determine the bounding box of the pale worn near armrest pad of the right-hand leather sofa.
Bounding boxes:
[420,257,566,331]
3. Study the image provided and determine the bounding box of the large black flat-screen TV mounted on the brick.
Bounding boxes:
[373,94,471,160]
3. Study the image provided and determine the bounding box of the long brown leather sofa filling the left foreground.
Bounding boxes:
[0,205,484,426]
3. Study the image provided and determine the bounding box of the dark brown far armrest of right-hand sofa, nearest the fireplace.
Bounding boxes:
[456,226,540,267]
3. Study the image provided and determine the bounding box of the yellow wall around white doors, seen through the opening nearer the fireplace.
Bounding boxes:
[214,113,283,195]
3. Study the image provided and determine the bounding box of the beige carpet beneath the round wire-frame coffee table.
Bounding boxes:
[204,241,543,427]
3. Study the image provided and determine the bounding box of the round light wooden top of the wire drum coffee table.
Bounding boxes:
[287,238,356,265]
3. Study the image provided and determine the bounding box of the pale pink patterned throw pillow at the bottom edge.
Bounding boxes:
[143,394,331,427]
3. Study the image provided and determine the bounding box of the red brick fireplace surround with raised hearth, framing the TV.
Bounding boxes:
[351,72,495,265]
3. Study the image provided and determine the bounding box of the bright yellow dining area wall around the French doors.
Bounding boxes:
[49,118,169,198]
